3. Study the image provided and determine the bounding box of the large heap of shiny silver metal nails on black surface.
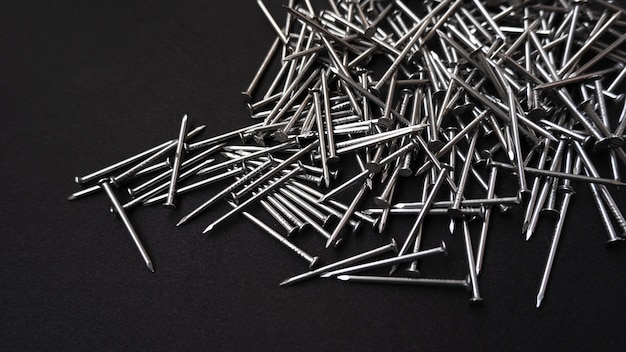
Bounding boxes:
[71,0,626,307]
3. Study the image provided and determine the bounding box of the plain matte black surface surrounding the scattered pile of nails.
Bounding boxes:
[0,0,626,351]
